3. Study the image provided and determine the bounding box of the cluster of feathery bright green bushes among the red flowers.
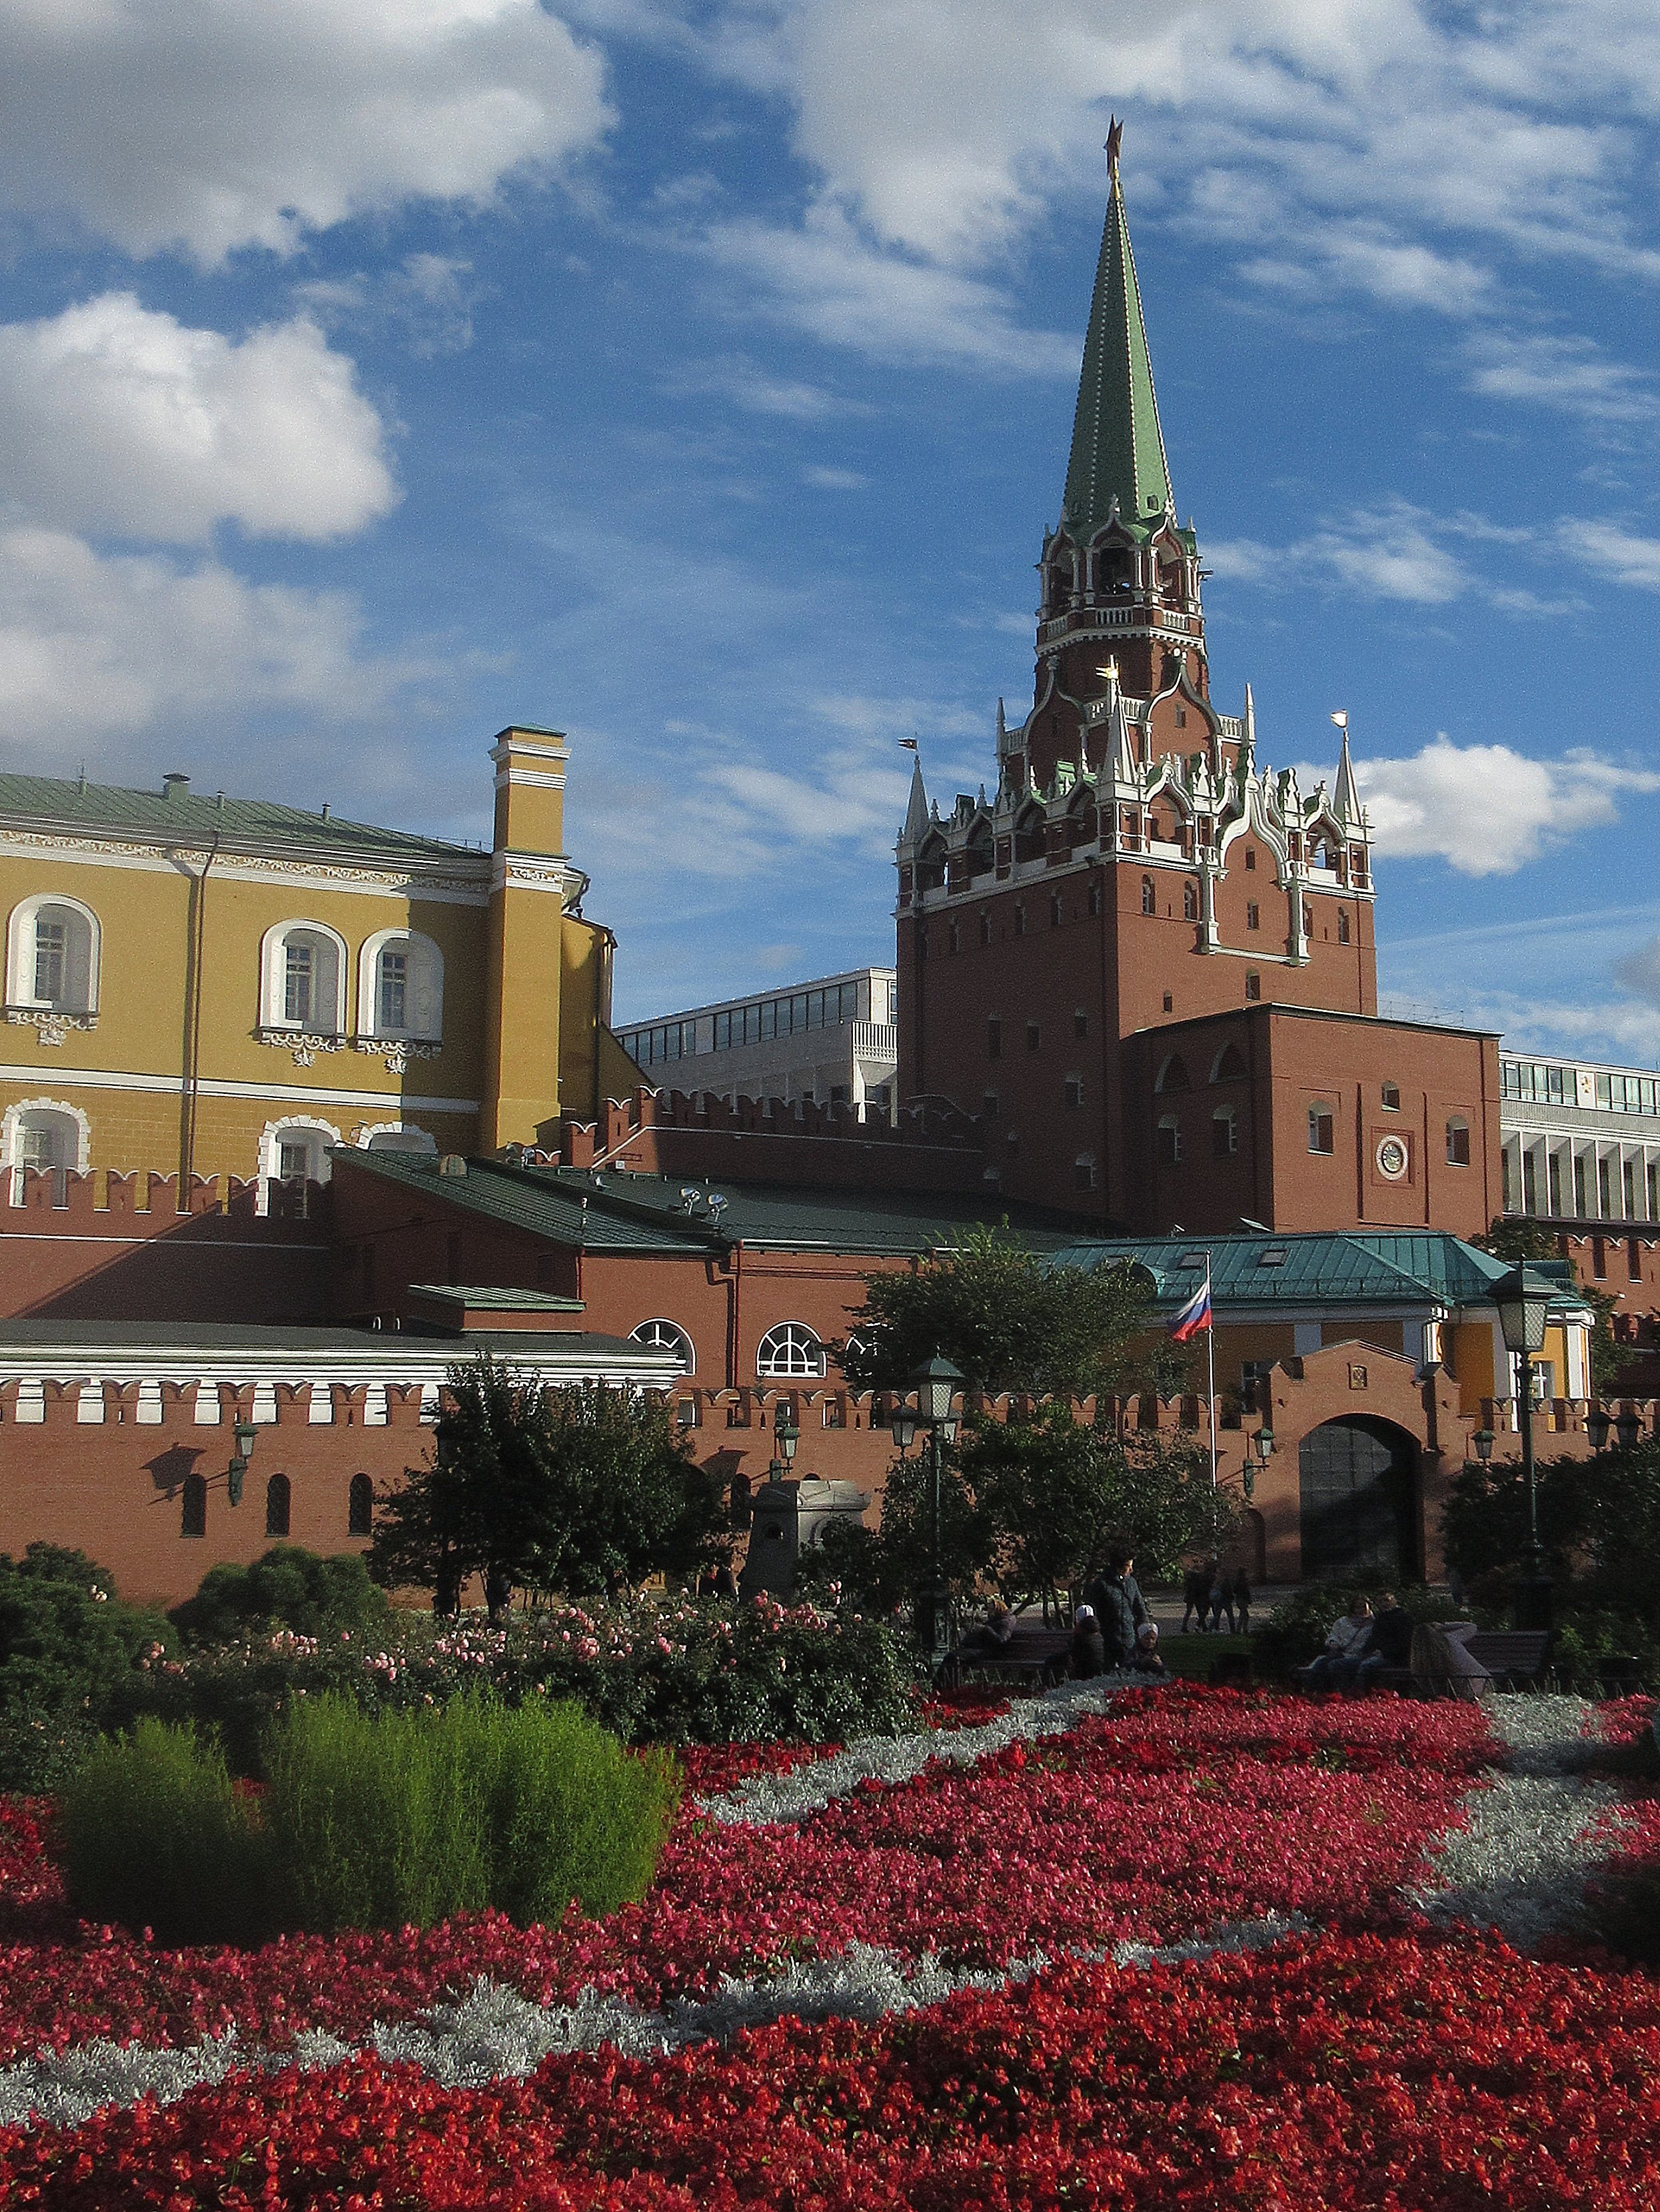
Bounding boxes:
[62,1694,680,1944]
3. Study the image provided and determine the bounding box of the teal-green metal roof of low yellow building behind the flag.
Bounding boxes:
[1052,1230,1578,1307]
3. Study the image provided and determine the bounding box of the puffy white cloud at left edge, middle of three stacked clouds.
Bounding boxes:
[0,292,397,542]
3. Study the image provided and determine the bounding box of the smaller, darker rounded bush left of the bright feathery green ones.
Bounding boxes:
[60,1721,268,1944]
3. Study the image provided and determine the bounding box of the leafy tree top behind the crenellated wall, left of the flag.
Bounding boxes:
[839,1225,1186,1398]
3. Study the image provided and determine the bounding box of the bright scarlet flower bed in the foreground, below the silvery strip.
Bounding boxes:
[0,1936,1660,2212]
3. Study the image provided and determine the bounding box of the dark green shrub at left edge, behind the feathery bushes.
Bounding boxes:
[0,1544,175,1790]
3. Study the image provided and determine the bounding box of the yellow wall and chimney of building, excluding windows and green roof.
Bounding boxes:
[0,730,633,1177]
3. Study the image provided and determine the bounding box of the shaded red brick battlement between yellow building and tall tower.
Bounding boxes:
[524,1084,987,1190]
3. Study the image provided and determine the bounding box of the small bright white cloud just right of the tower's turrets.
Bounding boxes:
[1337,737,1660,876]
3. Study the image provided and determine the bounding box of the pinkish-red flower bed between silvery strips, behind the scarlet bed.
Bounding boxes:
[0,1692,1487,2061]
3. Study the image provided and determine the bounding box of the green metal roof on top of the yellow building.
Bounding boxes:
[0,776,482,867]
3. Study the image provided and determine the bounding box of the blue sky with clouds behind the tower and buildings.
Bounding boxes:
[0,0,1660,1064]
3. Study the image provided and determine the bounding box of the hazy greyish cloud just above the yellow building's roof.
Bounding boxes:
[0,528,418,772]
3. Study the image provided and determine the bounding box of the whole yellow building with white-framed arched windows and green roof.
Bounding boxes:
[0,730,640,1188]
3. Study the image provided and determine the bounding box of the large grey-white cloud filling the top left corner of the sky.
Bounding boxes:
[0,0,611,265]
